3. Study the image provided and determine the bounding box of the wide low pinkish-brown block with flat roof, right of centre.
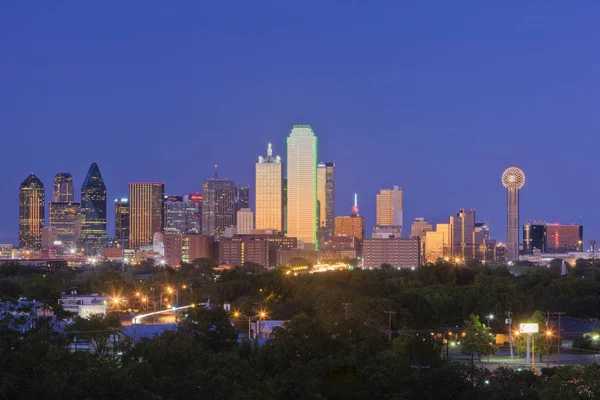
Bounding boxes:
[363,238,421,269]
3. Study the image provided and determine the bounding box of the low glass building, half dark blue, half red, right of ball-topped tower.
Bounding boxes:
[523,221,583,254]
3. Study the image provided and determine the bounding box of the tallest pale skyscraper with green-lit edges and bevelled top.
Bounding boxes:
[287,125,319,247]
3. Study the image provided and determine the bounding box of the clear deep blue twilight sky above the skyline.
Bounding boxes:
[0,0,600,244]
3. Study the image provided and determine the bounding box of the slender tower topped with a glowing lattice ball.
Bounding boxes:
[502,167,525,261]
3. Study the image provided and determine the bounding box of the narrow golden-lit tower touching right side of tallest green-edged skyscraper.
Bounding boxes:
[317,162,335,244]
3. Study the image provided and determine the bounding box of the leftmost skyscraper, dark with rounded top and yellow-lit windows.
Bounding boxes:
[19,173,45,250]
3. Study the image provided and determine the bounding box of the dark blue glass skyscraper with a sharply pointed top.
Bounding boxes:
[79,162,108,256]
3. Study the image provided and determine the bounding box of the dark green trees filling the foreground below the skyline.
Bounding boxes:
[0,263,600,399]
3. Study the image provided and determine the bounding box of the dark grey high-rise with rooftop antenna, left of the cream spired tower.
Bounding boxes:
[202,166,235,238]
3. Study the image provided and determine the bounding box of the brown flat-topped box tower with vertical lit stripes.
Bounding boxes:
[129,182,165,249]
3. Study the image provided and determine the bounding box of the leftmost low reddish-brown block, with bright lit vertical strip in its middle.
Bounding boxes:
[163,234,214,267]
